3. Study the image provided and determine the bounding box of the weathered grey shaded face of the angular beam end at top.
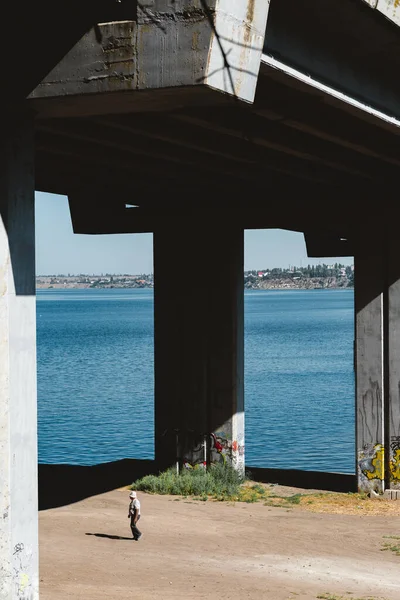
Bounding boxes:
[30,13,209,99]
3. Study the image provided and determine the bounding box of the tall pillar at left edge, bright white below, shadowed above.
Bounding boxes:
[0,114,38,600]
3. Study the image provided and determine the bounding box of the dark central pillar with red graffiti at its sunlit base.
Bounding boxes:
[154,218,244,470]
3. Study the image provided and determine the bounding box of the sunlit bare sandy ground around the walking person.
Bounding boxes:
[40,490,400,600]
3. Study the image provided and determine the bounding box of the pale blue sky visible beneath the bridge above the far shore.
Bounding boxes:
[36,192,353,275]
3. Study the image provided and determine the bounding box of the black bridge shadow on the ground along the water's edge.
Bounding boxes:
[39,458,357,510]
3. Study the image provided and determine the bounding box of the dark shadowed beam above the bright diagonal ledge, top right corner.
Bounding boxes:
[264,0,400,117]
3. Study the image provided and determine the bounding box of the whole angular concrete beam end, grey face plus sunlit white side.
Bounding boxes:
[30,0,269,117]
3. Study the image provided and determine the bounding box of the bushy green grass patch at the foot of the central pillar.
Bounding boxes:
[131,464,244,500]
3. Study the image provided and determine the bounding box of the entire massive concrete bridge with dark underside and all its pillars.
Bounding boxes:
[0,0,400,600]
